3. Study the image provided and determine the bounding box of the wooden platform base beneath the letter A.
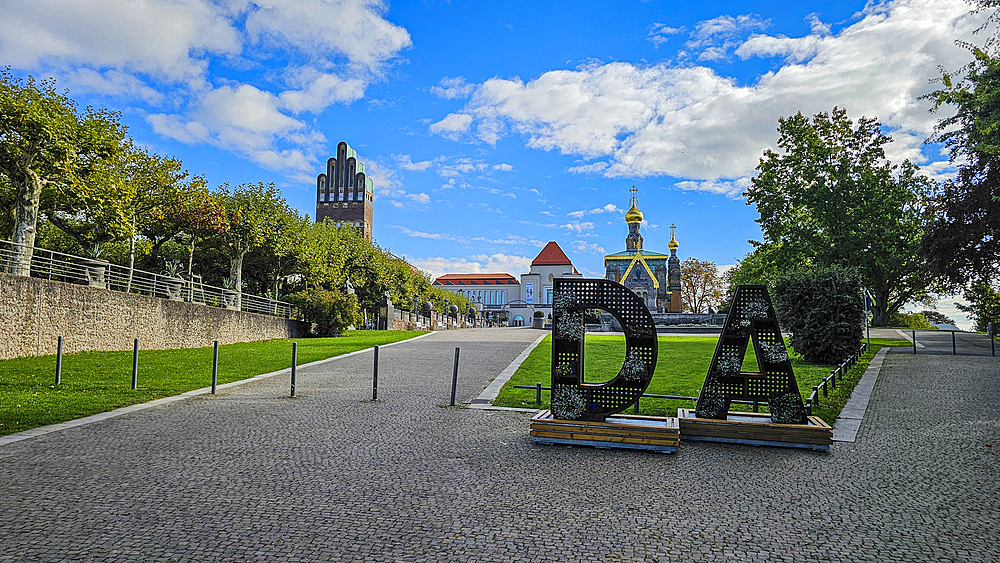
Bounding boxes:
[677,409,833,450]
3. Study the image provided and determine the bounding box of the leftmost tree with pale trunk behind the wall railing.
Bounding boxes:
[0,67,124,275]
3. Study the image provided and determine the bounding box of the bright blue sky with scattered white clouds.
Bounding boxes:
[0,0,985,325]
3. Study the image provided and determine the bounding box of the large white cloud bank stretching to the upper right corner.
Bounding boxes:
[440,0,984,194]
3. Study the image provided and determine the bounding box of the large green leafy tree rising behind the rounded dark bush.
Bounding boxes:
[744,108,936,326]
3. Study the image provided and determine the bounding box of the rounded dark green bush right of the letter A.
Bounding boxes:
[774,268,865,364]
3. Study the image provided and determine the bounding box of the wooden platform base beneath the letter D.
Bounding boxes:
[531,410,680,453]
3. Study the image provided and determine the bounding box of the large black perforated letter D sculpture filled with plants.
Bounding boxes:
[552,278,657,421]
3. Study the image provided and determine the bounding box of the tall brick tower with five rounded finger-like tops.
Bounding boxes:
[316,141,374,240]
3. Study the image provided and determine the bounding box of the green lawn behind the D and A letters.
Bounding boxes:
[493,334,876,422]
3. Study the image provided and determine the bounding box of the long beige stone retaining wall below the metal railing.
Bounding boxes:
[0,273,309,359]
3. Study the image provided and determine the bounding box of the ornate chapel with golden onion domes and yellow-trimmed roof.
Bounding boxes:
[604,186,681,313]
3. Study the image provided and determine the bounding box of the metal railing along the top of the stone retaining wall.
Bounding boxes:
[0,240,299,319]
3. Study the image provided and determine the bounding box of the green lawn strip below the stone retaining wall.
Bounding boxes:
[0,331,423,436]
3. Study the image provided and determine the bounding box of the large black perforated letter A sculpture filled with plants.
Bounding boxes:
[695,285,808,424]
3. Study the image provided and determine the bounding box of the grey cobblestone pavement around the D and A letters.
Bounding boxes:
[0,329,1000,562]
